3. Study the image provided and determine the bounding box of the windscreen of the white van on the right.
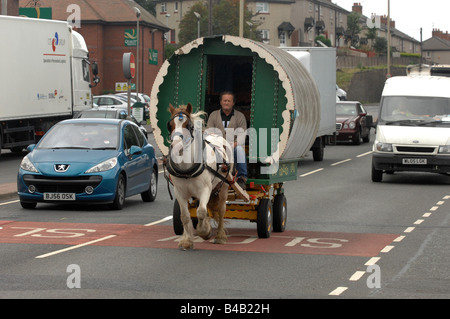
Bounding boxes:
[380,96,450,122]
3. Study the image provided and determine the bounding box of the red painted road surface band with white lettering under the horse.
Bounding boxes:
[0,221,398,257]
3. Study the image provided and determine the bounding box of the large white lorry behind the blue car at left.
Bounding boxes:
[0,16,99,154]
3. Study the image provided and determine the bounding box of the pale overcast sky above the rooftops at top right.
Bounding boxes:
[332,0,450,41]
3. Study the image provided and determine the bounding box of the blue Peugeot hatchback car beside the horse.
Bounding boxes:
[17,119,158,210]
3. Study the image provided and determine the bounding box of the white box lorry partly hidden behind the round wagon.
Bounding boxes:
[281,47,336,161]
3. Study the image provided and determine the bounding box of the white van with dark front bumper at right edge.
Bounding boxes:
[372,75,450,182]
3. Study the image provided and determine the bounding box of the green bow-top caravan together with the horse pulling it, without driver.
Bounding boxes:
[150,35,320,248]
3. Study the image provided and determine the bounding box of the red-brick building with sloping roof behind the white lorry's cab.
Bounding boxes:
[16,0,168,95]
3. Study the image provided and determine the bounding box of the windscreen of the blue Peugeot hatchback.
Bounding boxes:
[37,123,119,150]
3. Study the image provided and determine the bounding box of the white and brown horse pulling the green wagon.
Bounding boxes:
[166,103,232,250]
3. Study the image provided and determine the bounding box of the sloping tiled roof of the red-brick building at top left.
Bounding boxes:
[19,0,169,31]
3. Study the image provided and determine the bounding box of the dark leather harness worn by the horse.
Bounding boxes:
[162,111,234,199]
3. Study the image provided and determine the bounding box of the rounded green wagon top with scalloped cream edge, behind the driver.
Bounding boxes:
[150,35,320,168]
